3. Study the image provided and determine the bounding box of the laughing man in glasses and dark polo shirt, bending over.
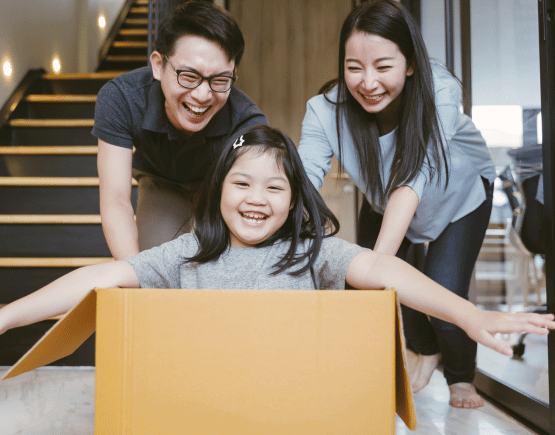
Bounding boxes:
[92,1,267,260]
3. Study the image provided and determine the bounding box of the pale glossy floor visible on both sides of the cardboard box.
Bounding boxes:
[0,367,544,435]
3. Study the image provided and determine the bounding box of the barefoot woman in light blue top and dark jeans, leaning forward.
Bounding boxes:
[299,0,496,407]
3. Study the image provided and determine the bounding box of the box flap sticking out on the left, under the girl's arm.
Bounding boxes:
[2,290,96,379]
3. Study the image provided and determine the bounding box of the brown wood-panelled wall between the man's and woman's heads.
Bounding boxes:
[229,0,351,143]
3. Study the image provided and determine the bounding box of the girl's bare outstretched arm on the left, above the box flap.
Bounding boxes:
[0,260,140,334]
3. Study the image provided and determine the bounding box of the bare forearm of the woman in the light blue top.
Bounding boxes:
[374,186,418,255]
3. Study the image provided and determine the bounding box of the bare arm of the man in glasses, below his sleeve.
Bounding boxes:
[97,139,139,260]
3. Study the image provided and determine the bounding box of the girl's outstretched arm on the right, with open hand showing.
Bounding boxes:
[346,251,555,356]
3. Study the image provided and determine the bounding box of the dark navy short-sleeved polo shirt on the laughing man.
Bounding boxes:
[92,67,268,184]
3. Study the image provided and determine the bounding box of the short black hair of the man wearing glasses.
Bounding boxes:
[154,0,245,66]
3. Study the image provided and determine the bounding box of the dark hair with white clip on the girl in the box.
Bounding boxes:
[186,125,339,276]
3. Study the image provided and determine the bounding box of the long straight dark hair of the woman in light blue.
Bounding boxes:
[320,0,449,206]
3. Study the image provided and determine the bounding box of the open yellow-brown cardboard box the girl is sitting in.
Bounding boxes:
[4,289,416,435]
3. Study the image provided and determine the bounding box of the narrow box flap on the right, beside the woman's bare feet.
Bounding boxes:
[395,292,416,430]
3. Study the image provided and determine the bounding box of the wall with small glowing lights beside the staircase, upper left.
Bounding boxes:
[0,0,125,106]
